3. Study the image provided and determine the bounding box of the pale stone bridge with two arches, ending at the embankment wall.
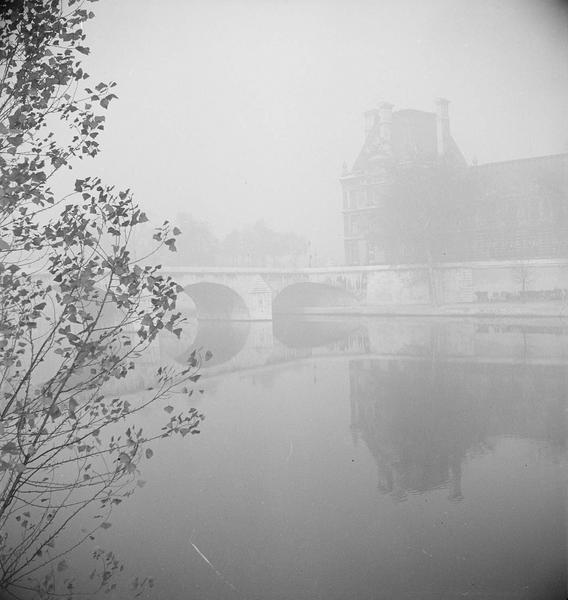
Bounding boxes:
[163,267,367,321]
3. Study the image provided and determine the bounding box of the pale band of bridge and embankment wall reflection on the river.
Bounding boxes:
[156,317,568,380]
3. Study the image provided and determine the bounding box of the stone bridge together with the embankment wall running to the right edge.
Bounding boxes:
[163,259,568,321]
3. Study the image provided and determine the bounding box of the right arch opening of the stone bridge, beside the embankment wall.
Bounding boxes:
[272,281,357,314]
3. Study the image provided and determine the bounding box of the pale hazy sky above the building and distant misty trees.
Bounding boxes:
[82,0,568,260]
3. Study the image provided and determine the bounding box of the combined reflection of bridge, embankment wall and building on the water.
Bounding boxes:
[162,317,568,501]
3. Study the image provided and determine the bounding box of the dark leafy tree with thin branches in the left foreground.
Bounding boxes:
[0,0,204,598]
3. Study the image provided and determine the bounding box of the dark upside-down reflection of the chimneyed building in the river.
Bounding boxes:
[349,359,568,500]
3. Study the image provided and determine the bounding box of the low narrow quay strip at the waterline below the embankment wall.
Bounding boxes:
[301,302,568,318]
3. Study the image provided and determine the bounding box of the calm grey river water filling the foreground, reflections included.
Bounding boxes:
[81,318,568,600]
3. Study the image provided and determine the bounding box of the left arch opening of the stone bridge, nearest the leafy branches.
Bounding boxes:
[184,281,250,320]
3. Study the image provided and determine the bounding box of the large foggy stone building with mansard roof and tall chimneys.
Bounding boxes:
[341,99,568,265]
